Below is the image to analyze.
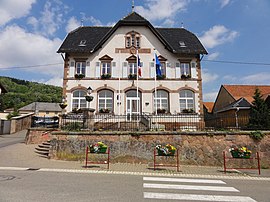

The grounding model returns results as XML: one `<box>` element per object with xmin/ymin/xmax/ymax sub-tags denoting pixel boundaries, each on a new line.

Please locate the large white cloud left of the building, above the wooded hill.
<box><xmin>0</xmin><ymin>25</ymin><xmax>63</xmax><ymax>80</ymax></box>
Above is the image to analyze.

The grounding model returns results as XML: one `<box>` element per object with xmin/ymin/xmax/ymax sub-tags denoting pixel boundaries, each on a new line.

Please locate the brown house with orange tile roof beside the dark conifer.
<box><xmin>206</xmin><ymin>85</ymin><xmax>270</xmax><ymax>128</ymax></box>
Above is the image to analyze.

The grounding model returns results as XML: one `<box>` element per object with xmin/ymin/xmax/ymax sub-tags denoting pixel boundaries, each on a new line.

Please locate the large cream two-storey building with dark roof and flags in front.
<box><xmin>57</xmin><ymin>12</ymin><xmax>207</xmax><ymax>131</ymax></box>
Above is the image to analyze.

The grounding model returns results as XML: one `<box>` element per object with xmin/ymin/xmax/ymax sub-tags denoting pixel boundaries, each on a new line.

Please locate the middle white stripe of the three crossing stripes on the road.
<box><xmin>143</xmin><ymin>183</ymin><xmax>239</xmax><ymax>192</ymax></box>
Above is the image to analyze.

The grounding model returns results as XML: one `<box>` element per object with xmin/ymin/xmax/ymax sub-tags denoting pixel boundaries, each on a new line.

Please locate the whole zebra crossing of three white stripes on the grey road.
<box><xmin>143</xmin><ymin>177</ymin><xmax>256</xmax><ymax>202</ymax></box>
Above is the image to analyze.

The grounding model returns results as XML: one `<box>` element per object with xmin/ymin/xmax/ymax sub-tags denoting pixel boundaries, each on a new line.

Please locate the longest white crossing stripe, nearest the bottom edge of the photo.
<box><xmin>143</xmin><ymin>192</ymin><xmax>256</xmax><ymax>202</ymax></box>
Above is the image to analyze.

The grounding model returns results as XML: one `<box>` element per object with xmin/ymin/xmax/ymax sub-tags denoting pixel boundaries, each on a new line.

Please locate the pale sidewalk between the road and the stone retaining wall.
<box><xmin>0</xmin><ymin>133</ymin><xmax>270</xmax><ymax>180</ymax></box>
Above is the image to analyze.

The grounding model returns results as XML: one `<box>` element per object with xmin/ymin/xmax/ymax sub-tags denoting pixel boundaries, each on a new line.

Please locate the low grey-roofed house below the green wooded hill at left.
<box><xmin>18</xmin><ymin>102</ymin><xmax>62</xmax><ymax>117</ymax></box>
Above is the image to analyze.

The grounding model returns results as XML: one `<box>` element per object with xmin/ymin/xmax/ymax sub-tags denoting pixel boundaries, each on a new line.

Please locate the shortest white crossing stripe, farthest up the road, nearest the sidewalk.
<box><xmin>143</xmin><ymin>177</ymin><xmax>226</xmax><ymax>184</ymax></box>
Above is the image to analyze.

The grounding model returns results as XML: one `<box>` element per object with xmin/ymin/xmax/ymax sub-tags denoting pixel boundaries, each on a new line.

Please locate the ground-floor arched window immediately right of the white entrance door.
<box><xmin>154</xmin><ymin>90</ymin><xmax>169</xmax><ymax>113</ymax></box>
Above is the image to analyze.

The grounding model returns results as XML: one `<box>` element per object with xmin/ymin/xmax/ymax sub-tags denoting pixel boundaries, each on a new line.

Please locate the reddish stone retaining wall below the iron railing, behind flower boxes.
<box><xmin>27</xmin><ymin>129</ymin><xmax>270</xmax><ymax>168</ymax></box>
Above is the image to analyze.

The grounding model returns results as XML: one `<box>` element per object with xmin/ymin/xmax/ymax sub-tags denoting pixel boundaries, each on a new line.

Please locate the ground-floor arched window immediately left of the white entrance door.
<box><xmin>98</xmin><ymin>90</ymin><xmax>113</xmax><ymax>113</ymax></box>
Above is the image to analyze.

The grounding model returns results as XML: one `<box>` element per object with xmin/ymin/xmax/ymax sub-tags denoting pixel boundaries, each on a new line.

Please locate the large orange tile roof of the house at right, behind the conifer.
<box><xmin>223</xmin><ymin>85</ymin><xmax>270</xmax><ymax>103</ymax></box>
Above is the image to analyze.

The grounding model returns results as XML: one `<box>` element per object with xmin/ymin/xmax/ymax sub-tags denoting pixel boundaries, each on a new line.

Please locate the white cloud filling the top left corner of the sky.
<box><xmin>0</xmin><ymin>0</ymin><xmax>36</xmax><ymax>26</ymax></box>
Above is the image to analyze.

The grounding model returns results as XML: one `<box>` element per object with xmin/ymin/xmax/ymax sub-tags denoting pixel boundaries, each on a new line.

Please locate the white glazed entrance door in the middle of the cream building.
<box><xmin>127</xmin><ymin>97</ymin><xmax>140</xmax><ymax>121</ymax></box>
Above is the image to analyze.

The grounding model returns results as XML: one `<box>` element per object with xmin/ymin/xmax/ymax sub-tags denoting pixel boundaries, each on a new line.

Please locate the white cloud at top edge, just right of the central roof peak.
<box><xmin>135</xmin><ymin>0</ymin><xmax>188</xmax><ymax>24</ymax></box>
